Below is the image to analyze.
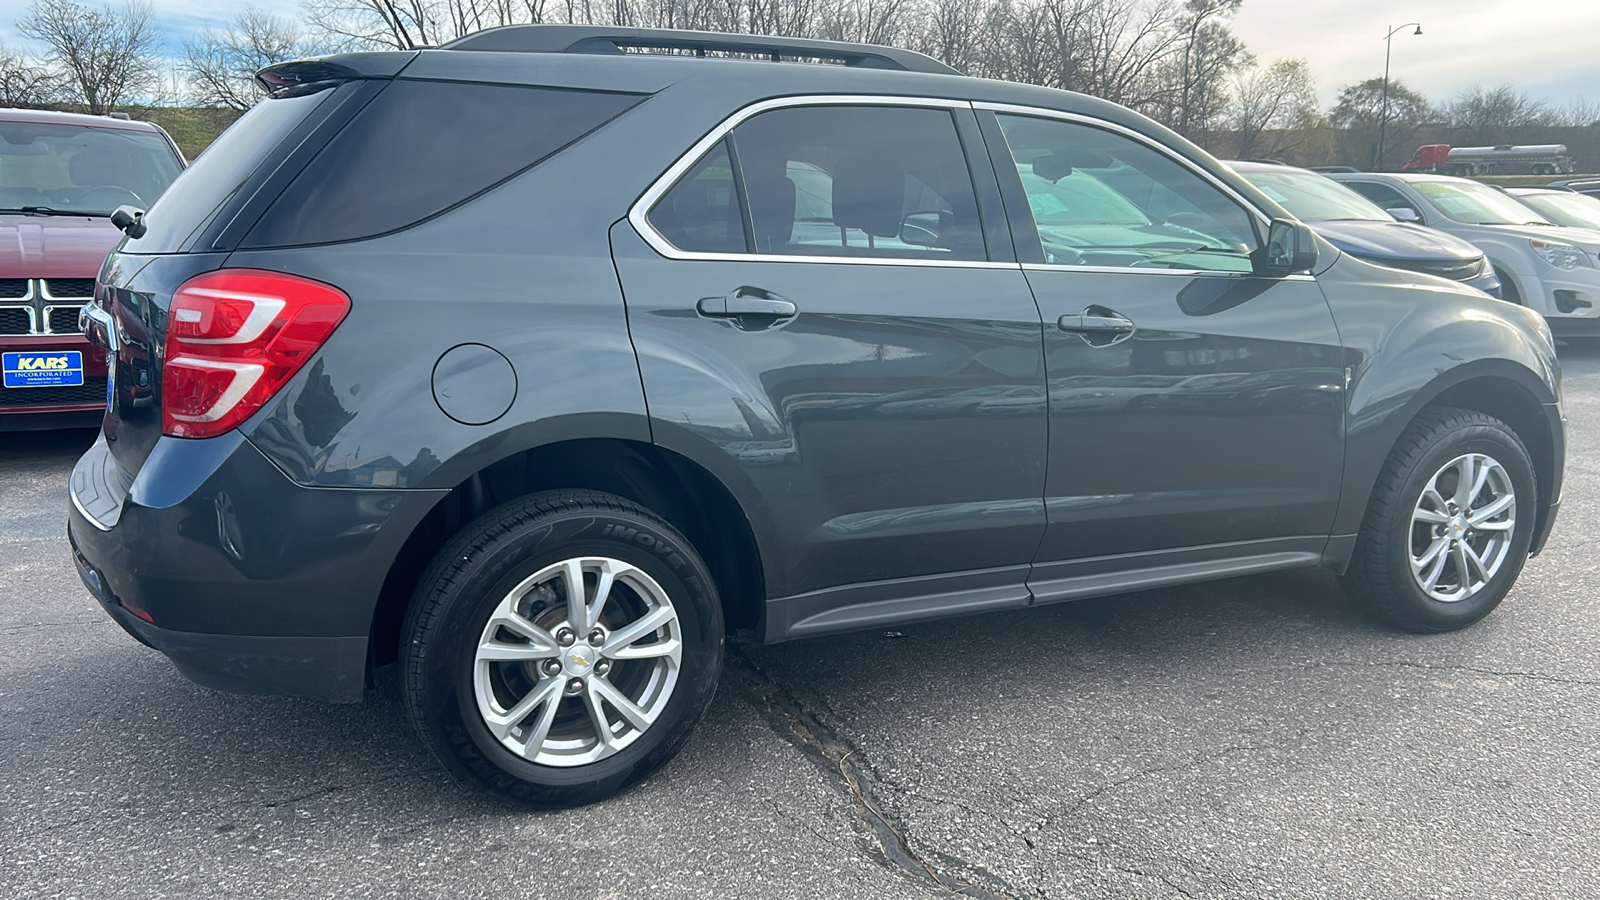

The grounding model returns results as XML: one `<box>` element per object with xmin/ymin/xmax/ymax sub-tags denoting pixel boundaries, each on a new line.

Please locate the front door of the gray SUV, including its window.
<box><xmin>979</xmin><ymin>109</ymin><xmax>1346</xmax><ymax>601</ymax></box>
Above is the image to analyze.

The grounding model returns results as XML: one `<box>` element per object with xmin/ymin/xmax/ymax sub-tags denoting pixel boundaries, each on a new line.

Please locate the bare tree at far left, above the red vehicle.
<box><xmin>16</xmin><ymin>0</ymin><xmax>160</xmax><ymax>114</ymax></box>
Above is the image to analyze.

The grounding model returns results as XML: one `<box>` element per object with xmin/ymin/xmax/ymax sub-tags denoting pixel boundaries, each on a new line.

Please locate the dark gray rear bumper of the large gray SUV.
<box><xmin>67</xmin><ymin>432</ymin><xmax>442</xmax><ymax>701</ymax></box>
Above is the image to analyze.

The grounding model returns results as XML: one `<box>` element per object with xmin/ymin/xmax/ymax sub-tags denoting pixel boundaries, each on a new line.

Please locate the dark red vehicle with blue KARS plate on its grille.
<box><xmin>0</xmin><ymin>109</ymin><xmax>186</xmax><ymax>431</ymax></box>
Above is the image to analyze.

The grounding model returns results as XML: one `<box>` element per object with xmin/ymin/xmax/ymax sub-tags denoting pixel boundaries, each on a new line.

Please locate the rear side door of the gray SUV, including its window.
<box><xmin>613</xmin><ymin>98</ymin><xmax>1048</xmax><ymax>639</ymax></box>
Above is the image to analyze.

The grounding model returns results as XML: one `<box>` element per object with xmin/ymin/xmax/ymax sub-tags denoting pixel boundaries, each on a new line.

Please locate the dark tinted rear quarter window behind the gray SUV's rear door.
<box><xmin>240</xmin><ymin>80</ymin><xmax>643</xmax><ymax>247</ymax></box>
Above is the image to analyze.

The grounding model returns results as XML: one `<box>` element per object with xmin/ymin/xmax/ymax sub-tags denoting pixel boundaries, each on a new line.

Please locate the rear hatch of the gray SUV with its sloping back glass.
<box><xmin>85</xmin><ymin>53</ymin><xmax>414</xmax><ymax>474</ymax></box>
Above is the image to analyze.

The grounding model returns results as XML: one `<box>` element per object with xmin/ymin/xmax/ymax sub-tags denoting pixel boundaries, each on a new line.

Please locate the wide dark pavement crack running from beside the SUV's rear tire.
<box><xmin>725</xmin><ymin>647</ymin><xmax>1018</xmax><ymax>900</ymax></box>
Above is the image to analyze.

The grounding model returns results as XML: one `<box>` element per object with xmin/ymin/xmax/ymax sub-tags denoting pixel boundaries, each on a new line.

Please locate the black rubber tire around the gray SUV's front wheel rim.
<box><xmin>1344</xmin><ymin>407</ymin><xmax>1538</xmax><ymax>634</ymax></box>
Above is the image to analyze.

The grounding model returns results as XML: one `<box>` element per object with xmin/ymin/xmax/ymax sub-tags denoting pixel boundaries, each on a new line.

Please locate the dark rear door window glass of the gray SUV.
<box><xmin>650</xmin><ymin>106</ymin><xmax>987</xmax><ymax>259</ymax></box>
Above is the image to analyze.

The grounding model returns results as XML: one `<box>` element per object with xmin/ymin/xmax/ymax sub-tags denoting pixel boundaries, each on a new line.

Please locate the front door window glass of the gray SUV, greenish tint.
<box><xmin>998</xmin><ymin>115</ymin><xmax>1258</xmax><ymax>272</ymax></box>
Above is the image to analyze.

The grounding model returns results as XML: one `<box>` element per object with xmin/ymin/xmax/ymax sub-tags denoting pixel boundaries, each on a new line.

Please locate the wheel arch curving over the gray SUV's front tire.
<box><xmin>1333</xmin><ymin>359</ymin><xmax>1560</xmax><ymax>554</ymax></box>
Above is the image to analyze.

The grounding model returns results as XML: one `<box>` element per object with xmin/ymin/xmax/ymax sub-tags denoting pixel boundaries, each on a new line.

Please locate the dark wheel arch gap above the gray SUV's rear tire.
<box><xmin>370</xmin><ymin>428</ymin><xmax>770</xmax><ymax>665</ymax></box>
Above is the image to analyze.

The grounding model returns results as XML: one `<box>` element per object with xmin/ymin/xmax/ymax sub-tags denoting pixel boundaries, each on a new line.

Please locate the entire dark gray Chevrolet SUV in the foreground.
<box><xmin>69</xmin><ymin>26</ymin><xmax>1565</xmax><ymax>806</ymax></box>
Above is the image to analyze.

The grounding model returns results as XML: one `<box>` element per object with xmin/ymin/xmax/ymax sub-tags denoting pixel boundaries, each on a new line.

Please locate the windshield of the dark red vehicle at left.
<box><xmin>0</xmin><ymin>122</ymin><xmax>179</xmax><ymax>216</ymax></box>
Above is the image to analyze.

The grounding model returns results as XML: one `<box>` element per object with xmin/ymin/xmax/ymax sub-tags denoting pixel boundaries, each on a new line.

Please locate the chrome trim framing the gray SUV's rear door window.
<box><xmin>627</xmin><ymin>94</ymin><xmax>1021</xmax><ymax>271</ymax></box>
